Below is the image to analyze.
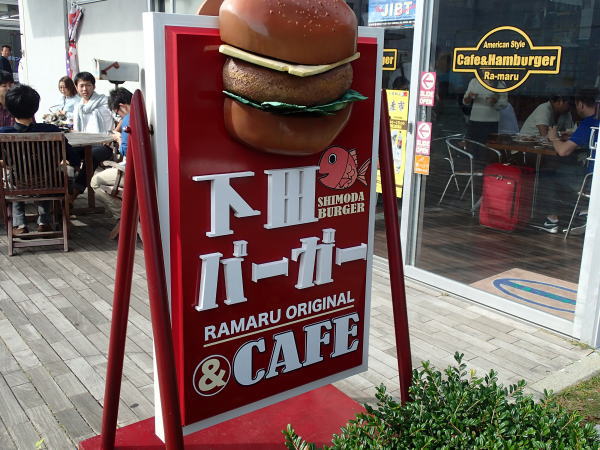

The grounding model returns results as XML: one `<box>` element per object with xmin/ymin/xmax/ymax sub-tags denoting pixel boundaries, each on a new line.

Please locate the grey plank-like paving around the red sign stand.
<box><xmin>0</xmin><ymin>216</ymin><xmax>600</xmax><ymax>449</ymax></box>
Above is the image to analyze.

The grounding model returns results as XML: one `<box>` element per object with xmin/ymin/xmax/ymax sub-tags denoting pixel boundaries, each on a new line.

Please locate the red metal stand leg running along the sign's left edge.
<box><xmin>130</xmin><ymin>90</ymin><xmax>183</xmax><ymax>449</ymax></box>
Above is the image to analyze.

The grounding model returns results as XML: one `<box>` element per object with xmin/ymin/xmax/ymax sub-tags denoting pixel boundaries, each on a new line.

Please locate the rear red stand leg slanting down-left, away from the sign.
<box><xmin>102</xmin><ymin>139</ymin><xmax>138</xmax><ymax>450</ymax></box>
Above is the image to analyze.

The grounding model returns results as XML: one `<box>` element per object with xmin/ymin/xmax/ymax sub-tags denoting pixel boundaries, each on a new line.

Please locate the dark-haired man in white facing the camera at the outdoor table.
<box><xmin>71</xmin><ymin>72</ymin><xmax>114</xmax><ymax>201</ymax></box>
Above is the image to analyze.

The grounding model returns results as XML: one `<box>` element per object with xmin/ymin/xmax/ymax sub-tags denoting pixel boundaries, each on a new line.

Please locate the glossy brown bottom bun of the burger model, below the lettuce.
<box><xmin>224</xmin><ymin>98</ymin><xmax>352</xmax><ymax>155</ymax></box>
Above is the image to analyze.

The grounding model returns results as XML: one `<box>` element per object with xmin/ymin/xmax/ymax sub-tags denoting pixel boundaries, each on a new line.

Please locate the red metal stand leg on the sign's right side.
<box><xmin>379</xmin><ymin>90</ymin><xmax>412</xmax><ymax>403</ymax></box>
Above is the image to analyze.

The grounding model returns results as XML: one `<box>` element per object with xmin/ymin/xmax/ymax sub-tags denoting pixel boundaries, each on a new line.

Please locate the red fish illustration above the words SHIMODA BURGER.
<box><xmin>319</xmin><ymin>147</ymin><xmax>371</xmax><ymax>189</ymax></box>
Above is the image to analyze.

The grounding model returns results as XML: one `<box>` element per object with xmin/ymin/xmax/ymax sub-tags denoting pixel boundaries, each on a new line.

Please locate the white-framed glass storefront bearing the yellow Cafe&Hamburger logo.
<box><xmin>151</xmin><ymin>0</ymin><xmax>600</xmax><ymax>346</ymax></box>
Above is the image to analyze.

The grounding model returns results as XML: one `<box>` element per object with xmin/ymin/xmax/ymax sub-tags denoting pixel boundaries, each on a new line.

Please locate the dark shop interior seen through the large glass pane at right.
<box><xmin>366</xmin><ymin>0</ymin><xmax>600</xmax><ymax>320</ymax></box>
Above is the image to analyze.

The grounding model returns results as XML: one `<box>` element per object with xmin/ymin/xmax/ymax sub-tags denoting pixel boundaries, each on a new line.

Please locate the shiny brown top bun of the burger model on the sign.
<box><xmin>219</xmin><ymin>0</ymin><xmax>357</xmax><ymax>65</ymax></box>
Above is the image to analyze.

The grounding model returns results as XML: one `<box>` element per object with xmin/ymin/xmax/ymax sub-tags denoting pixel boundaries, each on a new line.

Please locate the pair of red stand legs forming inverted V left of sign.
<box><xmin>102</xmin><ymin>90</ymin><xmax>183</xmax><ymax>449</ymax></box>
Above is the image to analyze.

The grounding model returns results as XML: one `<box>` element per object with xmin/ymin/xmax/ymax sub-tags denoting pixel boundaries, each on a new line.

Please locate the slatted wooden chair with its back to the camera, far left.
<box><xmin>0</xmin><ymin>133</ymin><xmax>69</xmax><ymax>256</ymax></box>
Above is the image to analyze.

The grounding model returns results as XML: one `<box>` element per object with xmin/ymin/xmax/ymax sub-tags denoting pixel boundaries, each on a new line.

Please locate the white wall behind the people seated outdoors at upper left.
<box><xmin>19</xmin><ymin>0</ymin><xmax>148</xmax><ymax>121</ymax></box>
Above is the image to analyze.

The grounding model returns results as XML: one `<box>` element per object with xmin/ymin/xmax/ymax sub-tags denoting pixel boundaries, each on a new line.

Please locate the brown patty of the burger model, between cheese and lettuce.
<box><xmin>223</xmin><ymin>58</ymin><xmax>352</xmax><ymax>106</ymax></box>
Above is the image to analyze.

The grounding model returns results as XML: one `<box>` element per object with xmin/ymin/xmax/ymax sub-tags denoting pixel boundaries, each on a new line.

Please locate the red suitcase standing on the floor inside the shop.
<box><xmin>479</xmin><ymin>163</ymin><xmax>534</xmax><ymax>231</ymax></box>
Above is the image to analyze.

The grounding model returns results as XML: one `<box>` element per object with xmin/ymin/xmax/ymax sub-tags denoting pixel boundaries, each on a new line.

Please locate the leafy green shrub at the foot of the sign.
<box><xmin>283</xmin><ymin>353</ymin><xmax>600</xmax><ymax>450</ymax></box>
